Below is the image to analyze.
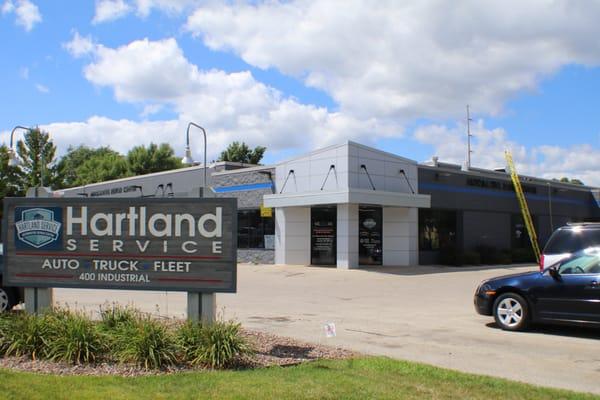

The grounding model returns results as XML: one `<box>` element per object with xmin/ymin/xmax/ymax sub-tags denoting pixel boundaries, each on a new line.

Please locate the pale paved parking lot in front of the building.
<box><xmin>55</xmin><ymin>265</ymin><xmax>600</xmax><ymax>394</ymax></box>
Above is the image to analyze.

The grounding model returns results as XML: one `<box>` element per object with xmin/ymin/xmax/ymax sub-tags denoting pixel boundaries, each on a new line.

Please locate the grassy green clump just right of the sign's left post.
<box><xmin>46</xmin><ymin>312</ymin><xmax>107</xmax><ymax>364</ymax></box>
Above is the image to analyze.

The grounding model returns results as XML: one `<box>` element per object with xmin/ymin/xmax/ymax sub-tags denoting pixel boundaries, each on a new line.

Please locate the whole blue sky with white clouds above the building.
<box><xmin>0</xmin><ymin>0</ymin><xmax>600</xmax><ymax>185</ymax></box>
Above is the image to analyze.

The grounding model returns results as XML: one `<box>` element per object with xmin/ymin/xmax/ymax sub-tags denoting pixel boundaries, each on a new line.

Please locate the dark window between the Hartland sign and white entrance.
<box><xmin>238</xmin><ymin>209</ymin><xmax>275</xmax><ymax>249</ymax></box>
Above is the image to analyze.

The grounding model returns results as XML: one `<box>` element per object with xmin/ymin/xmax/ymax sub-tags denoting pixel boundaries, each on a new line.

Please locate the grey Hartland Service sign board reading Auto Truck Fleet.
<box><xmin>3</xmin><ymin>198</ymin><xmax>237</xmax><ymax>292</ymax></box>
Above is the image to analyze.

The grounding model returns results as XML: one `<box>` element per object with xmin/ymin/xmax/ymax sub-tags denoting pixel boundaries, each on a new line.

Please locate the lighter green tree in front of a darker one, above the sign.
<box><xmin>74</xmin><ymin>150</ymin><xmax>129</xmax><ymax>186</ymax></box>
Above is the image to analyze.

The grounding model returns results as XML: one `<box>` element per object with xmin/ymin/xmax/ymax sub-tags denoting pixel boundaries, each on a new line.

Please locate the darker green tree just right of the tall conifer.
<box><xmin>56</xmin><ymin>145</ymin><xmax>119</xmax><ymax>188</ymax></box>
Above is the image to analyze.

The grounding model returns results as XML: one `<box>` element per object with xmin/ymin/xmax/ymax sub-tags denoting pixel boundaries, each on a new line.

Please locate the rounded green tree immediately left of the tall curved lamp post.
<box><xmin>127</xmin><ymin>143</ymin><xmax>182</xmax><ymax>175</ymax></box>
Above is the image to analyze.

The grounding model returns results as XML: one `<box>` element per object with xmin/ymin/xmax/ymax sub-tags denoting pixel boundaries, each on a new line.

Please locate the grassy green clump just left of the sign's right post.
<box><xmin>113</xmin><ymin>317</ymin><xmax>178</xmax><ymax>369</ymax></box>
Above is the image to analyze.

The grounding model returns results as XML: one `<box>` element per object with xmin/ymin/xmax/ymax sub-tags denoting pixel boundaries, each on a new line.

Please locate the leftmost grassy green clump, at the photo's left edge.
<box><xmin>4</xmin><ymin>314</ymin><xmax>52</xmax><ymax>360</ymax></box>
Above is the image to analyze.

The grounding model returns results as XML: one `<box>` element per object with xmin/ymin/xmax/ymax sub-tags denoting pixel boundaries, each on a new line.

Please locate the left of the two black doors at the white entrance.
<box><xmin>310</xmin><ymin>206</ymin><xmax>337</xmax><ymax>265</ymax></box>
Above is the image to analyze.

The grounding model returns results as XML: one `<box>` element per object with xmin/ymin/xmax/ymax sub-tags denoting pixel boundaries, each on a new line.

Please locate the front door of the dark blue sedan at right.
<box><xmin>532</xmin><ymin>255</ymin><xmax>600</xmax><ymax>323</ymax></box>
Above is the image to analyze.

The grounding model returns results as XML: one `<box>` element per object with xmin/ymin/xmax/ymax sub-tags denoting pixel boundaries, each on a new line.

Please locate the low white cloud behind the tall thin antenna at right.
<box><xmin>414</xmin><ymin>120</ymin><xmax>600</xmax><ymax>186</ymax></box>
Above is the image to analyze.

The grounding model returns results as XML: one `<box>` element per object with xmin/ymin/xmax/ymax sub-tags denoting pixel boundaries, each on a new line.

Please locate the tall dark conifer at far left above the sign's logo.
<box><xmin>17</xmin><ymin>128</ymin><xmax>57</xmax><ymax>189</ymax></box>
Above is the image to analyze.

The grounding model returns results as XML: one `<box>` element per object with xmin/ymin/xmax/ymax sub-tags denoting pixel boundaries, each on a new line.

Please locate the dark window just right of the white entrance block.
<box><xmin>419</xmin><ymin>209</ymin><xmax>456</xmax><ymax>251</ymax></box>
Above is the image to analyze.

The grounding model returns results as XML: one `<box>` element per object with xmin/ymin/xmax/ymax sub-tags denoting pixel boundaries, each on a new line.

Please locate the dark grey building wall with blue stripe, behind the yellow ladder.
<box><xmin>419</xmin><ymin>166</ymin><xmax>600</xmax><ymax>263</ymax></box>
